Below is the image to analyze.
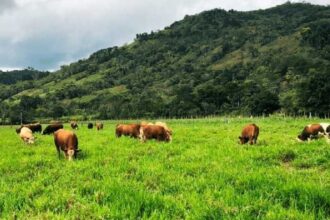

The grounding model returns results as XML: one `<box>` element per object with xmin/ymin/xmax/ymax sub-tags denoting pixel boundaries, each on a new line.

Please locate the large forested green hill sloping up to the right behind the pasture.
<box><xmin>0</xmin><ymin>3</ymin><xmax>330</xmax><ymax>122</ymax></box>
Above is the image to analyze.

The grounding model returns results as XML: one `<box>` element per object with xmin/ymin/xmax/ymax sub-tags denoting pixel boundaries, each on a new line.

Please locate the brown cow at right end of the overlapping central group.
<box><xmin>139</xmin><ymin>125</ymin><xmax>172</xmax><ymax>142</ymax></box>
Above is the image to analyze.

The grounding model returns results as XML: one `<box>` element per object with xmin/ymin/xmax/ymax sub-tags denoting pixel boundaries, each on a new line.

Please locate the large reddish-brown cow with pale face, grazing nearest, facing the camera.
<box><xmin>54</xmin><ymin>129</ymin><xmax>80</xmax><ymax>160</ymax></box>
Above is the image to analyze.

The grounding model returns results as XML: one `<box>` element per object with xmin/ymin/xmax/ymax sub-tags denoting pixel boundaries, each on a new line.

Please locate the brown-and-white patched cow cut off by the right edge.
<box><xmin>297</xmin><ymin>123</ymin><xmax>330</xmax><ymax>141</ymax></box>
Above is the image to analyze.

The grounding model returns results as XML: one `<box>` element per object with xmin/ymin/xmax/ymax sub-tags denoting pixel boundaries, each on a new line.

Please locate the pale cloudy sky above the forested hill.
<box><xmin>0</xmin><ymin>0</ymin><xmax>330</xmax><ymax>71</ymax></box>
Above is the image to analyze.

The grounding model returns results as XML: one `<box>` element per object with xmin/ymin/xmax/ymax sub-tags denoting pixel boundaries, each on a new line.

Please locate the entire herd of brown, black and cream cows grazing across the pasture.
<box><xmin>16</xmin><ymin>121</ymin><xmax>330</xmax><ymax>160</ymax></box>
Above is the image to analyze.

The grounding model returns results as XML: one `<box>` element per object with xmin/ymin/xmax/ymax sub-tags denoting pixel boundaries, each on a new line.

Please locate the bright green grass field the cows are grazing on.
<box><xmin>0</xmin><ymin>118</ymin><xmax>330</xmax><ymax>219</ymax></box>
